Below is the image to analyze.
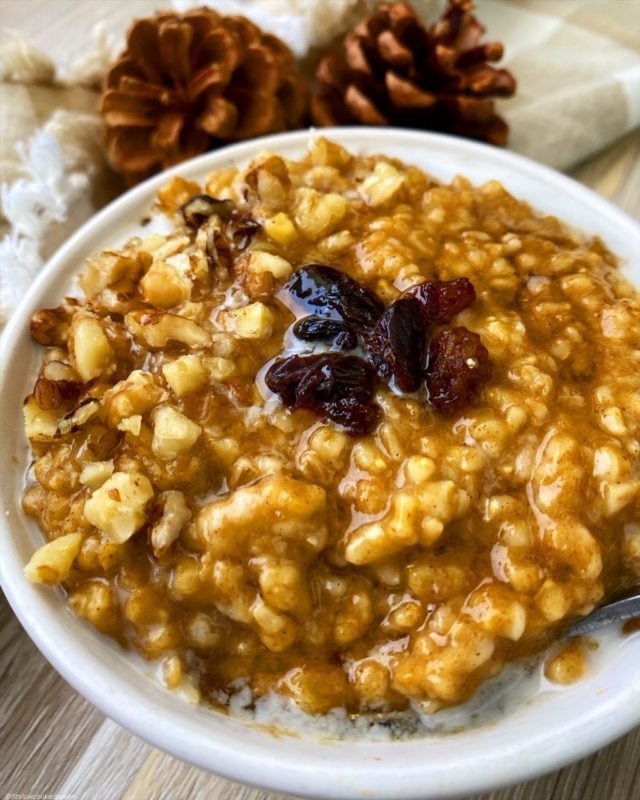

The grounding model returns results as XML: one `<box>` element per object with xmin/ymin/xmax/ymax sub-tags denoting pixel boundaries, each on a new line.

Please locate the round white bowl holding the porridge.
<box><xmin>0</xmin><ymin>128</ymin><xmax>640</xmax><ymax>800</ymax></box>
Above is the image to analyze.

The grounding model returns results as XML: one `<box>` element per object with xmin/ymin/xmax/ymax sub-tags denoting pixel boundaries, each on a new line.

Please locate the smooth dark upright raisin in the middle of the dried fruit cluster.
<box><xmin>366</xmin><ymin>297</ymin><xmax>427</xmax><ymax>392</ymax></box>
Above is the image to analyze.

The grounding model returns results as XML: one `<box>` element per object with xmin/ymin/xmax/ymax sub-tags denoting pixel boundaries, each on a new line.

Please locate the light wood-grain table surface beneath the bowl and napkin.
<box><xmin>0</xmin><ymin>0</ymin><xmax>640</xmax><ymax>800</ymax></box>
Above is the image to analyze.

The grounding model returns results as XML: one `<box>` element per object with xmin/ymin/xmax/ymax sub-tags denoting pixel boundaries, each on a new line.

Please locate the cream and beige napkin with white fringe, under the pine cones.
<box><xmin>0</xmin><ymin>0</ymin><xmax>640</xmax><ymax>327</ymax></box>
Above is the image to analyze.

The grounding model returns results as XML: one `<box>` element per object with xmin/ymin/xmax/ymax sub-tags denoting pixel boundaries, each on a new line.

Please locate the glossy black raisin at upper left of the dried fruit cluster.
<box><xmin>286</xmin><ymin>264</ymin><xmax>384</xmax><ymax>332</ymax></box>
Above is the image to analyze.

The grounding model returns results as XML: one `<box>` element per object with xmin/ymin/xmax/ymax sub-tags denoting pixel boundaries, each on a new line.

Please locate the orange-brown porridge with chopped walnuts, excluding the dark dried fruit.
<box><xmin>23</xmin><ymin>138</ymin><xmax>640</xmax><ymax>713</ymax></box>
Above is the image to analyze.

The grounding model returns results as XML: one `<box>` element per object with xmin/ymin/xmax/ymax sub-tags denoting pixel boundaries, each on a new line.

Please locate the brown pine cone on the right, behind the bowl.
<box><xmin>311</xmin><ymin>0</ymin><xmax>516</xmax><ymax>145</ymax></box>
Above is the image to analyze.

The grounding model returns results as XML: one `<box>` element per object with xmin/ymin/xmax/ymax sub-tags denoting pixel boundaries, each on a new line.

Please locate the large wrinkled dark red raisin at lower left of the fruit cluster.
<box><xmin>265</xmin><ymin>353</ymin><xmax>380</xmax><ymax>436</ymax></box>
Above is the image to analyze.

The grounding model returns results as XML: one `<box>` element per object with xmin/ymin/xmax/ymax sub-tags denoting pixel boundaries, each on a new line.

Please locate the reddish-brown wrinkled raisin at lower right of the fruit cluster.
<box><xmin>426</xmin><ymin>328</ymin><xmax>491</xmax><ymax>413</ymax></box>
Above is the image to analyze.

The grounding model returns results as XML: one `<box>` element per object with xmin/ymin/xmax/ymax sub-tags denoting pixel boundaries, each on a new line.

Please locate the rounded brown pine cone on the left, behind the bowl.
<box><xmin>100</xmin><ymin>8</ymin><xmax>306</xmax><ymax>184</ymax></box>
